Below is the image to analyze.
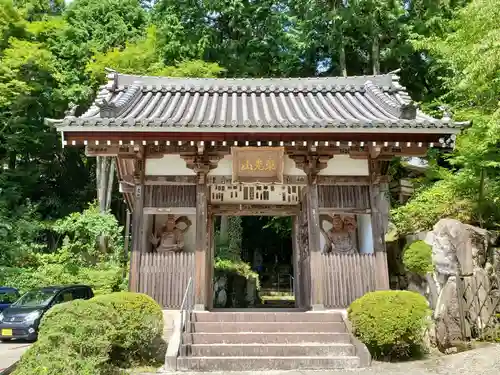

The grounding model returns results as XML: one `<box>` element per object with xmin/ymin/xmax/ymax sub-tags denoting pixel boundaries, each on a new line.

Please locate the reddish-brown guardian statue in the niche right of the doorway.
<box><xmin>320</xmin><ymin>215</ymin><xmax>358</xmax><ymax>254</ymax></box>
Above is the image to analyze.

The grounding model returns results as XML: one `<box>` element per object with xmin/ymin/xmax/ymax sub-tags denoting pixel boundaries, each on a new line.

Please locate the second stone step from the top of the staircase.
<box><xmin>191</xmin><ymin>322</ymin><xmax>346</xmax><ymax>333</ymax></box>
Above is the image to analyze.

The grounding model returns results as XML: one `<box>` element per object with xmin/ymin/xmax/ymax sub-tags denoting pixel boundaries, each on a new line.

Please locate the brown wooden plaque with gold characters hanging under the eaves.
<box><xmin>231</xmin><ymin>147</ymin><xmax>284</xmax><ymax>184</ymax></box>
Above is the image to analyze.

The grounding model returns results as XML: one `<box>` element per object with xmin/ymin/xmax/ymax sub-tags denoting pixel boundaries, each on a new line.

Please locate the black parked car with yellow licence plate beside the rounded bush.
<box><xmin>0</xmin><ymin>285</ymin><xmax>94</xmax><ymax>342</ymax></box>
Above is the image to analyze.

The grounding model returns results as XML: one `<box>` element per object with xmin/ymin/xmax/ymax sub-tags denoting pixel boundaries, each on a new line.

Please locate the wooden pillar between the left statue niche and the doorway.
<box><xmin>194</xmin><ymin>166</ymin><xmax>209</xmax><ymax>310</ymax></box>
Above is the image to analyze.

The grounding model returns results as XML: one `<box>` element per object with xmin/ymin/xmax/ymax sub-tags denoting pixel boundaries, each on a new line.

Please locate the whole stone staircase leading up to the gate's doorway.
<box><xmin>177</xmin><ymin>311</ymin><xmax>369</xmax><ymax>372</ymax></box>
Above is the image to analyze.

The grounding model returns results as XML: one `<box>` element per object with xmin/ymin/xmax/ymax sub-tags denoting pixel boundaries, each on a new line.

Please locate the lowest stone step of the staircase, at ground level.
<box><xmin>177</xmin><ymin>357</ymin><xmax>360</xmax><ymax>372</ymax></box>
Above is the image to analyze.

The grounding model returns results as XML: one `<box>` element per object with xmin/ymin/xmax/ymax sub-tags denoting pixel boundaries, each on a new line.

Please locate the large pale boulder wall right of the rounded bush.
<box><xmin>425</xmin><ymin>219</ymin><xmax>500</xmax><ymax>351</ymax></box>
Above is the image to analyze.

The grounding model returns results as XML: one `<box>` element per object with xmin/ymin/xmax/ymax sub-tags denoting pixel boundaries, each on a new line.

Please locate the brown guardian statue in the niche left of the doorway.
<box><xmin>151</xmin><ymin>215</ymin><xmax>191</xmax><ymax>254</ymax></box>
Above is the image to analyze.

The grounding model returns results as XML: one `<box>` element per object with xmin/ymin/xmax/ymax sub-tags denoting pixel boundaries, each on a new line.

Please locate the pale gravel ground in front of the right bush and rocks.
<box><xmin>152</xmin><ymin>344</ymin><xmax>500</xmax><ymax>375</ymax></box>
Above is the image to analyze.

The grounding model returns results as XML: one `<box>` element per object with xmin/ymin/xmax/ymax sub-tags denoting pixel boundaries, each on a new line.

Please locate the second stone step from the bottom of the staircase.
<box><xmin>185</xmin><ymin>343</ymin><xmax>355</xmax><ymax>357</ymax></box>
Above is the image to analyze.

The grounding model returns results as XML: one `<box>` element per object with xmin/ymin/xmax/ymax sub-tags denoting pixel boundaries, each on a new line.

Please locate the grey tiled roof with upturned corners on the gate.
<box><xmin>57</xmin><ymin>73</ymin><xmax>462</xmax><ymax>131</ymax></box>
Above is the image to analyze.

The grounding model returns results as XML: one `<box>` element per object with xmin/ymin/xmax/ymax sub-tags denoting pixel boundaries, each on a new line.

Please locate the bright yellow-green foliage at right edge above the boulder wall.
<box><xmin>393</xmin><ymin>0</ymin><xmax>500</xmax><ymax>233</ymax></box>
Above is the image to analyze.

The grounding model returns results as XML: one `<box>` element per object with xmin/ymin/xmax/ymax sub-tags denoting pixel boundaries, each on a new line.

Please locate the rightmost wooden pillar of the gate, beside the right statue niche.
<box><xmin>370</xmin><ymin>159</ymin><xmax>390</xmax><ymax>290</ymax></box>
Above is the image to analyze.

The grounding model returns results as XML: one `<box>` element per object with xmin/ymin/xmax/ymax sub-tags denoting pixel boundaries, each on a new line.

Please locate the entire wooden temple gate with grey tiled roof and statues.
<box><xmin>51</xmin><ymin>73</ymin><xmax>464</xmax><ymax>309</ymax></box>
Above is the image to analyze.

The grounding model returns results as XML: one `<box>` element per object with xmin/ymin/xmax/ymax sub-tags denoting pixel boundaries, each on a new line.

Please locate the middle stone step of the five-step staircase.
<box><xmin>183</xmin><ymin>332</ymin><xmax>351</xmax><ymax>345</ymax></box>
